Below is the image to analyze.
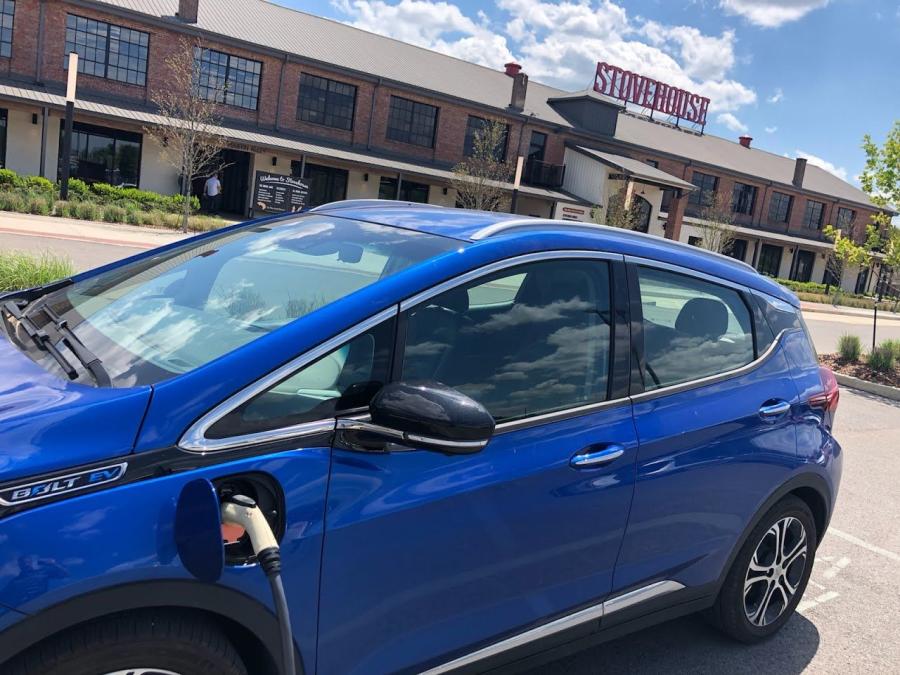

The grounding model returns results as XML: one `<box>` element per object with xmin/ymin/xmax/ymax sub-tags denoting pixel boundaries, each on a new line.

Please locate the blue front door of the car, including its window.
<box><xmin>318</xmin><ymin>253</ymin><xmax>636</xmax><ymax>673</ymax></box>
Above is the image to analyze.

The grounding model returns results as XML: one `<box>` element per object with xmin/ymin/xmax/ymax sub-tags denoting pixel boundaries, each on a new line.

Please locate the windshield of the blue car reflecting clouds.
<box><xmin>15</xmin><ymin>214</ymin><xmax>460</xmax><ymax>387</ymax></box>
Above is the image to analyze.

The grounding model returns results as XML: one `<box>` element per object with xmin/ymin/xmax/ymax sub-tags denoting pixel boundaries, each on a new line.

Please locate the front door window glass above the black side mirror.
<box><xmin>402</xmin><ymin>260</ymin><xmax>610</xmax><ymax>422</ymax></box>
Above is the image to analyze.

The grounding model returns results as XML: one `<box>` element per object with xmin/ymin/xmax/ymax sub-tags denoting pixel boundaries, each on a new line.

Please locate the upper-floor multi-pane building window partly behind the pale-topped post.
<box><xmin>64</xmin><ymin>14</ymin><xmax>150</xmax><ymax>87</ymax></box>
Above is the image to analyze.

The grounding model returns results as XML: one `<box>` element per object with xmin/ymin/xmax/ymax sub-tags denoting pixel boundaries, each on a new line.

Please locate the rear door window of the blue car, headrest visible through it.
<box><xmin>638</xmin><ymin>267</ymin><xmax>755</xmax><ymax>390</ymax></box>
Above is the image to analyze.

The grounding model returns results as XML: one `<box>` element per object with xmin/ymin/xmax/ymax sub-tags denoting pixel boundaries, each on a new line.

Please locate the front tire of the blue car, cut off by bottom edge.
<box><xmin>3</xmin><ymin>610</ymin><xmax>247</xmax><ymax>675</ymax></box>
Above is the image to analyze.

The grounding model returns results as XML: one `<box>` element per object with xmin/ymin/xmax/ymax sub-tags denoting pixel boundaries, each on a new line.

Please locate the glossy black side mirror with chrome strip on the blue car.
<box><xmin>339</xmin><ymin>381</ymin><xmax>494</xmax><ymax>455</ymax></box>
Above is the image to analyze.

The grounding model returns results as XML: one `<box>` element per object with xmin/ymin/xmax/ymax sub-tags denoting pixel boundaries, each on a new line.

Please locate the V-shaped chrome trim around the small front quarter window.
<box><xmin>178</xmin><ymin>305</ymin><xmax>399</xmax><ymax>454</ymax></box>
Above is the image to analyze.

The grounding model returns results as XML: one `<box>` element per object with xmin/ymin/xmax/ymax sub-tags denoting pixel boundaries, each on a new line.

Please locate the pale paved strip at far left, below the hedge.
<box><xmin>0</xmin><ymin>211</ymin><xmax>191</xmax><ymax>249</ymax></box>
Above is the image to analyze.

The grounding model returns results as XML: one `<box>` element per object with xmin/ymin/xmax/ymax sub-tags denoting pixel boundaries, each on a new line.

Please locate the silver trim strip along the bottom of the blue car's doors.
<box><xmin>421</xmin><ymin>579</ymin><xmax>684</xmax><ymax>675</ymax></box>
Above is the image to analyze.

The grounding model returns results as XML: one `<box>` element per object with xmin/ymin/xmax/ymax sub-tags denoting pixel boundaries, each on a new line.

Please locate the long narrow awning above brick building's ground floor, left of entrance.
<box><xmin>0</xmin><ymin>84</ymin><xmax>574</xmax><ymax>201</ymax></box>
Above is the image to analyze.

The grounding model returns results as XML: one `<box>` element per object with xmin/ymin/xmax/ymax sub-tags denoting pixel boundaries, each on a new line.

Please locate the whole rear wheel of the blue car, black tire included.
<box><xmin>708</xmin><ymin>495</ymin><xmax>818</xmax><ymax>643</ymax></box>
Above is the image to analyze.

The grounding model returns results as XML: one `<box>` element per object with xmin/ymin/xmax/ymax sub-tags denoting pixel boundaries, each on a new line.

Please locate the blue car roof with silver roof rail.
<box><xmin>312</xmin><ymin>199</ymin><xmax>799</xmax><ymax>306</ymax></box>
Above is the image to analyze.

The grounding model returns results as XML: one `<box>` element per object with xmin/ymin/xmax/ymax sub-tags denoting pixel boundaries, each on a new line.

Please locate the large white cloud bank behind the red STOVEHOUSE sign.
<box><xmin>332</xmin><ymin>0</ymin><xmax>756</xmax><ymax>113</ymax></box>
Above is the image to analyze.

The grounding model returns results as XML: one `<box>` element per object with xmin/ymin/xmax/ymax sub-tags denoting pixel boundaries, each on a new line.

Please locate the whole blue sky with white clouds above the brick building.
<box><xmin>276</xmin><ymin>0</ymin><xmax>900</xmax><ymax>182</ymax></box>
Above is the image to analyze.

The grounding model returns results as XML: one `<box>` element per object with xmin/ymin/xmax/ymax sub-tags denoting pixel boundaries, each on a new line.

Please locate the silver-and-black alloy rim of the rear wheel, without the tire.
<box><xmin>744</xmin><ymin>516</ymin><xmax>808</xmax><ymax>627</ymax></box>
